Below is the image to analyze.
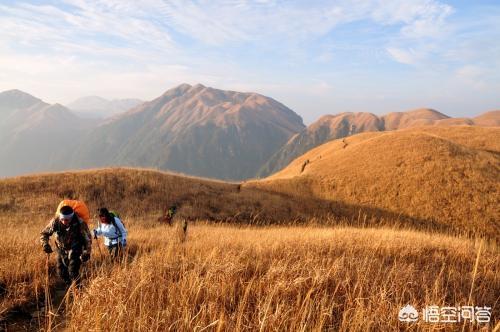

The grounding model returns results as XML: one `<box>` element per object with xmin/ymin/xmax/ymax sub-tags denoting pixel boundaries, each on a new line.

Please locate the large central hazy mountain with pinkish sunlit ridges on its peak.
<box><xmin>74</xmin><ymin>84</ymin><xmax>304</xmax><ymax>179</ymax></box>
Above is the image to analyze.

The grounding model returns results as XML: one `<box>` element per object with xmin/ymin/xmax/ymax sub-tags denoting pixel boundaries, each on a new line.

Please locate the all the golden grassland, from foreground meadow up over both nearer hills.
<box><xmin>0</xmin><ymin>127</ymin><xmax>500</xmax><ymax>331</ymax></box>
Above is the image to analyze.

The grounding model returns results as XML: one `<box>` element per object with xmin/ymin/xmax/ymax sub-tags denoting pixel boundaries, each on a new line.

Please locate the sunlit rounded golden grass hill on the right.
<box><xmin>249</xmin><ymin>127</ymin><xmax>500</xmax><ymax>238</ymax></box>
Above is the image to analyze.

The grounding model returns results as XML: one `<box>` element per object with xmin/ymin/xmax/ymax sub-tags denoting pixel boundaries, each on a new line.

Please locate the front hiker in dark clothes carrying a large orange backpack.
<box><xmin>40</xmin><ymin>205</ymin><xmax>92</xmax><ymax>285</ymax></box>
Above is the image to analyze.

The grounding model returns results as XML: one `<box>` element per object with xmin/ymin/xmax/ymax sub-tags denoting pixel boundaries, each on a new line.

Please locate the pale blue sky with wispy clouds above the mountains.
<box><xmin>0</xmin><ymin>0</ymin><xmax>500</xmax><ymax>124</ymax></box>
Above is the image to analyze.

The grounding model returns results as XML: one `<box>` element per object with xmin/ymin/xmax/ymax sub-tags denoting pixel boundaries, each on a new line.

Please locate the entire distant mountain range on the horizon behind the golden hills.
<box><xmin>0</xmin><ymin>84</ymin><xmax>500</xmax><ymax>180</ymax></box>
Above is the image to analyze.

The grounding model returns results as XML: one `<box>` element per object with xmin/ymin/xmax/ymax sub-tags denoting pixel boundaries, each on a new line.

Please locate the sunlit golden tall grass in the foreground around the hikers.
<box><xmin>0</xmin><ymin>218</ymin><xmax>500</xmax><ymax>331</ymax></box>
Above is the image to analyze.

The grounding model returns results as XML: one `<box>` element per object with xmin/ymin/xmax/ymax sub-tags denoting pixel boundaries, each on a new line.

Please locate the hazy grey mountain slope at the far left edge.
<box><xmin>0</xmin><ymin>90</ymin><xmax>91</xmax><ymax>176</ymax></box>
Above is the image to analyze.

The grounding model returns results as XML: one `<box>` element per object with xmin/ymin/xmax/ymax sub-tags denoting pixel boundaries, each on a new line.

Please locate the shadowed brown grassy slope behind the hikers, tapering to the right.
<box><xmin>0</xmin><ymin>168</ymin><xmax>476</xmax><ymax>233</ymax></box>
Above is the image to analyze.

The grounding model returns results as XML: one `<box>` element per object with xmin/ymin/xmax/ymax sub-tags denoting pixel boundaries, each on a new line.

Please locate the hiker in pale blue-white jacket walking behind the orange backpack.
<box><xmin>94</xmin><ymin>207</ymin><xmax>127</xmax><ymax>258</ymax></box>
